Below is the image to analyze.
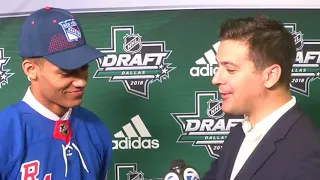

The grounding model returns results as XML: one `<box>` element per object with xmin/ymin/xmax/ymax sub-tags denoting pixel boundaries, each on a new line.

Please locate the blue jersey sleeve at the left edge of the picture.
<box><xmin>0</xmin><ymin>107</ymin><xmax>24</xmax><ymax>180</ymax></box>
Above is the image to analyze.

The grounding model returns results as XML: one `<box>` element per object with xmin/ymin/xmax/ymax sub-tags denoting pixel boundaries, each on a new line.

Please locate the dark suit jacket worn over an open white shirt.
<box><xmin>202</xmin><ymin>105</ymin><xmax>320</xmax><ymax>180</ymax></box>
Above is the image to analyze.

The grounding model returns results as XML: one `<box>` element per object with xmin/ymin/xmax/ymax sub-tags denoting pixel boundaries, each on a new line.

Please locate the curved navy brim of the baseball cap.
<box><xmin>44</xmin><ymin>44</ymin><xmax>104</xmax><ymax>70</ymax></box>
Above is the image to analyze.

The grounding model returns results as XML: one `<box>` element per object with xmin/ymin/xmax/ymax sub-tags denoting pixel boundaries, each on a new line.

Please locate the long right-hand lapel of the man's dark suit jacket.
<box><xmin>235</xmin><ymin>105</ymin><xmax>302</xmax><ymax>180</ymax></box>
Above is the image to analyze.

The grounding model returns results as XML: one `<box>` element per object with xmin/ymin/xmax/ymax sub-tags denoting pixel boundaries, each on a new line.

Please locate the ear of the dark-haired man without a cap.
<box><xmin>264</xmin><ymin>64</ymin><xmax>282</xmax><ymax>89</ymax></box>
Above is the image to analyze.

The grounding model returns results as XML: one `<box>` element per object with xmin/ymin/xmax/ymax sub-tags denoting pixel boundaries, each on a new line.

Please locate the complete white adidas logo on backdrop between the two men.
<box><xmin>112</xmin><ymin>115</ymin><xmax>159</xmax><ymax>149</ymax></box>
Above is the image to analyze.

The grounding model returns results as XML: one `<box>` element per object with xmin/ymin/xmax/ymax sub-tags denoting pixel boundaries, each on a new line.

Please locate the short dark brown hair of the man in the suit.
<box><xmin>219</xmin><ymin>15</ymin><xmax>297</xmax><ymax>88</ymax></box>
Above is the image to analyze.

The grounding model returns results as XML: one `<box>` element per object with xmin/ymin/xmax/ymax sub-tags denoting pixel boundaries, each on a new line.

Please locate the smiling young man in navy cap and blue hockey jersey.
<box><xmin>0</xmin><ymin>7</ymin><xmax>112</xmax><ymax>180</ymax></box>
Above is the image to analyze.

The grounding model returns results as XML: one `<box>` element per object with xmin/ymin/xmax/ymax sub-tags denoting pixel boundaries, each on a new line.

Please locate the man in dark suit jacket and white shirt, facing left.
<box><xmin>202</xmin><ymin>16</ymin><xmax>320</xmax><ymax>180</ymax></box>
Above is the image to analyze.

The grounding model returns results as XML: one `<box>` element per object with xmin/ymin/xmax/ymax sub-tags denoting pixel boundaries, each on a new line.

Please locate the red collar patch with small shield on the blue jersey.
<box><xmin>53</xmin><ymin>120</ymin><xmax>72</xmax><ymax>144</ymax></box>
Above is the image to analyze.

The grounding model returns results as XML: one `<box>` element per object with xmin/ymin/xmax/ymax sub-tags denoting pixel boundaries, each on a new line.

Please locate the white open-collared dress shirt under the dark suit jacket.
<box><xmin>230</xmin><ymin>96</ymin><xmax>296</xmax><ymax>180</ymax></box>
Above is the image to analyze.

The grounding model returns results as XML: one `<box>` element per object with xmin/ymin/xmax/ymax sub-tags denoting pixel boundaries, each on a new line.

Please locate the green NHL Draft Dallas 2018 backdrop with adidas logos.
<box><xmin>0</xmin><ymin>4</ymin><xmax>320</xmax><ymax>180</ymax></box>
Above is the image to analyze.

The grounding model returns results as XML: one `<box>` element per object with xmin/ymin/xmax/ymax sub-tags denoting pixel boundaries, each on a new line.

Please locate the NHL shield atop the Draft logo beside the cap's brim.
<box><xmin>123</xmin><ymin>34</ymin><xmax>142</xmax><ymax>54</ymax></box>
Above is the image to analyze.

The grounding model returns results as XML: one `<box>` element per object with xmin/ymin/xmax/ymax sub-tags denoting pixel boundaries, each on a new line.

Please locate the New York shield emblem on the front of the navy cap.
<box><xmin>59</xmin><ymin>19</ymin><xmax>81</xmax><ymax>42</ymax></box>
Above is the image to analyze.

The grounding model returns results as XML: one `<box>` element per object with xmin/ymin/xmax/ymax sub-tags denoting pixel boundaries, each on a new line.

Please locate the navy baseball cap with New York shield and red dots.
<box><xmin>19</xmin><ymin>7</ymin><xmax>103</xmax><ymax>70</ymax></box>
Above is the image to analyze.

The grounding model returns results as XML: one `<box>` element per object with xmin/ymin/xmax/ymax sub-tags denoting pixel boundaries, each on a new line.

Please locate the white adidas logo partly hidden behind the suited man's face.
<box><xmin>190</xmin><ymin>41</ymin><xmax>220</xmax><ymax>77</ymax></box>
